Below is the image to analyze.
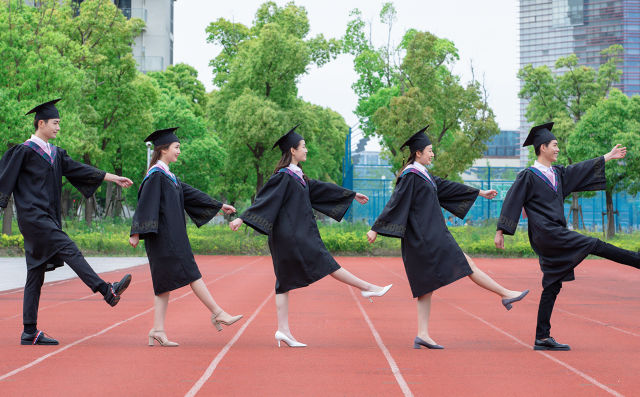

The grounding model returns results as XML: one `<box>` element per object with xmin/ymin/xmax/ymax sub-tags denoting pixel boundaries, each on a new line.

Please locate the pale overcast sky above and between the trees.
<box><xmin>174</xmin><ymin>0</ymin><xmax>519</xmax><ymax>130</ymax></box>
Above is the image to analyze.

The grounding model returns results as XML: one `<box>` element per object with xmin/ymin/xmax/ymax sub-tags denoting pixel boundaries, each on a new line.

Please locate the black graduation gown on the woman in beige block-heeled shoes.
<box><xmin>130</xmin><ymin>167</ymin><xmax>222</xmax><ymax>295</ymax></box>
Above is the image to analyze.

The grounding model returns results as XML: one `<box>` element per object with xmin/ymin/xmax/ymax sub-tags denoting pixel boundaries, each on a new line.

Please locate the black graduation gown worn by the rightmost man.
<box><xmin>498</xmin><ymin>157</ymin><xmax>607</xmax><ymax>287</ymax></box>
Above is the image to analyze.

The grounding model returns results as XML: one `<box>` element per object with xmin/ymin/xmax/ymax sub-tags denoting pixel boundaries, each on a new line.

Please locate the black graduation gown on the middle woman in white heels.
<box><xmin>240</xmin><ymin>169</ymin><xmax>356</xmax><ymax>294</ymax></box>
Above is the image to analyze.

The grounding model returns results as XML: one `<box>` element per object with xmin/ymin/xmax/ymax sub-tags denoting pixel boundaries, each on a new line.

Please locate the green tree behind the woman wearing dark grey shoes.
<box><xmin>344</xmin><ymin>3</ymin><xmax>499</xmax><ymax>179</ymax></box>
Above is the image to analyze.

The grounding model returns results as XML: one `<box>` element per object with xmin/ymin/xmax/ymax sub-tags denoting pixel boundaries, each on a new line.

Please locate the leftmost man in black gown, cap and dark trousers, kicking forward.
<box><xmin>0</xmin><ymin>99</ymin><xmax>132</xmax><ymax>345</ymax></box>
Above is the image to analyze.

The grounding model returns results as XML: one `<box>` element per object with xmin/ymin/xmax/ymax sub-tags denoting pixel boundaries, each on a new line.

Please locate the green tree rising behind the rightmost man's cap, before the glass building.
<box><xmin>518</xmin><ymin>45</ymin><xmax>622</xmax><ymax>229</ymax></box>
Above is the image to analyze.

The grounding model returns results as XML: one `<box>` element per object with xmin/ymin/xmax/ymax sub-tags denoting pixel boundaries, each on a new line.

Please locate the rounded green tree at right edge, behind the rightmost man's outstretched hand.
<box><xmin>567</xmin><ymin>88</ymin><xmax>640</xmax><ymax>238</ymax></box>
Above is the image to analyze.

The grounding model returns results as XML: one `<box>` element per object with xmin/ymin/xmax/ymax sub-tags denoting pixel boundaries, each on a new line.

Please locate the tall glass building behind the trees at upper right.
<box><xmin>519</xmin><ymin>0</ymin><xmax>640</xmax><ymax>166</ymax></box>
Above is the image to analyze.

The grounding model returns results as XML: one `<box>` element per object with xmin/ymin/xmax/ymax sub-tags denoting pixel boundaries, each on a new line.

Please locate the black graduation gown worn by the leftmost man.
<box><xmin>0</xmin><ymin>141</ymin><xmax>106</xmax><ymax>271</ymax></box>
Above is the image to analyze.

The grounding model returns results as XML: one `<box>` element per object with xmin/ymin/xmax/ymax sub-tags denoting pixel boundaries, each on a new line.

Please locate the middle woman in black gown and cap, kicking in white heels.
<box><xmin>229</xmin><ymin>126</ymin><xmax>391</xmax><ymax>347</ymax></box>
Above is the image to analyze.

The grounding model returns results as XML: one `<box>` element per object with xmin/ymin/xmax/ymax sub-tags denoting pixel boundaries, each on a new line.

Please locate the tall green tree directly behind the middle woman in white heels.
<box><xmin>207</xmin><ymin>2</ymin><xmax>347</xmax><ymax>202</ymax></box>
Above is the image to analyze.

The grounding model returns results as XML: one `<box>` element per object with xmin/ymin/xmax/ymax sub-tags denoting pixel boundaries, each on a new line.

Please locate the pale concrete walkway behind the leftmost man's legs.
<box><xmin>0</xmin><ymin>256</ymin><xmax>149</xmax><ymax>291</ymax></box>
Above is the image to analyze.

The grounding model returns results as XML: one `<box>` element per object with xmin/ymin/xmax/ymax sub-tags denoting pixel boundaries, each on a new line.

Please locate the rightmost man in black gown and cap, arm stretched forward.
<box><xmin>495</xmin><ymin>123</ymin><xmax>640</xmax><ymax>350</ymax></box>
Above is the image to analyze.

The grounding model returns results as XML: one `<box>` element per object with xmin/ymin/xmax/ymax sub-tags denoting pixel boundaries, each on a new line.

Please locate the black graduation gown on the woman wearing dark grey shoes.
<box><xmin>371</xmin><ymin>169</ymin><xmax>479</xmax><ymax>298</ymax></box>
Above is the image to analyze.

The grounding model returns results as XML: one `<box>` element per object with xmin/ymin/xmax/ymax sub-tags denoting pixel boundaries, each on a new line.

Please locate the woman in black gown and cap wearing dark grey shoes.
<box><xmin>367</xmin><ymin>126</ymin><xmax>529</xmax><ymax>349</ymax></box>
